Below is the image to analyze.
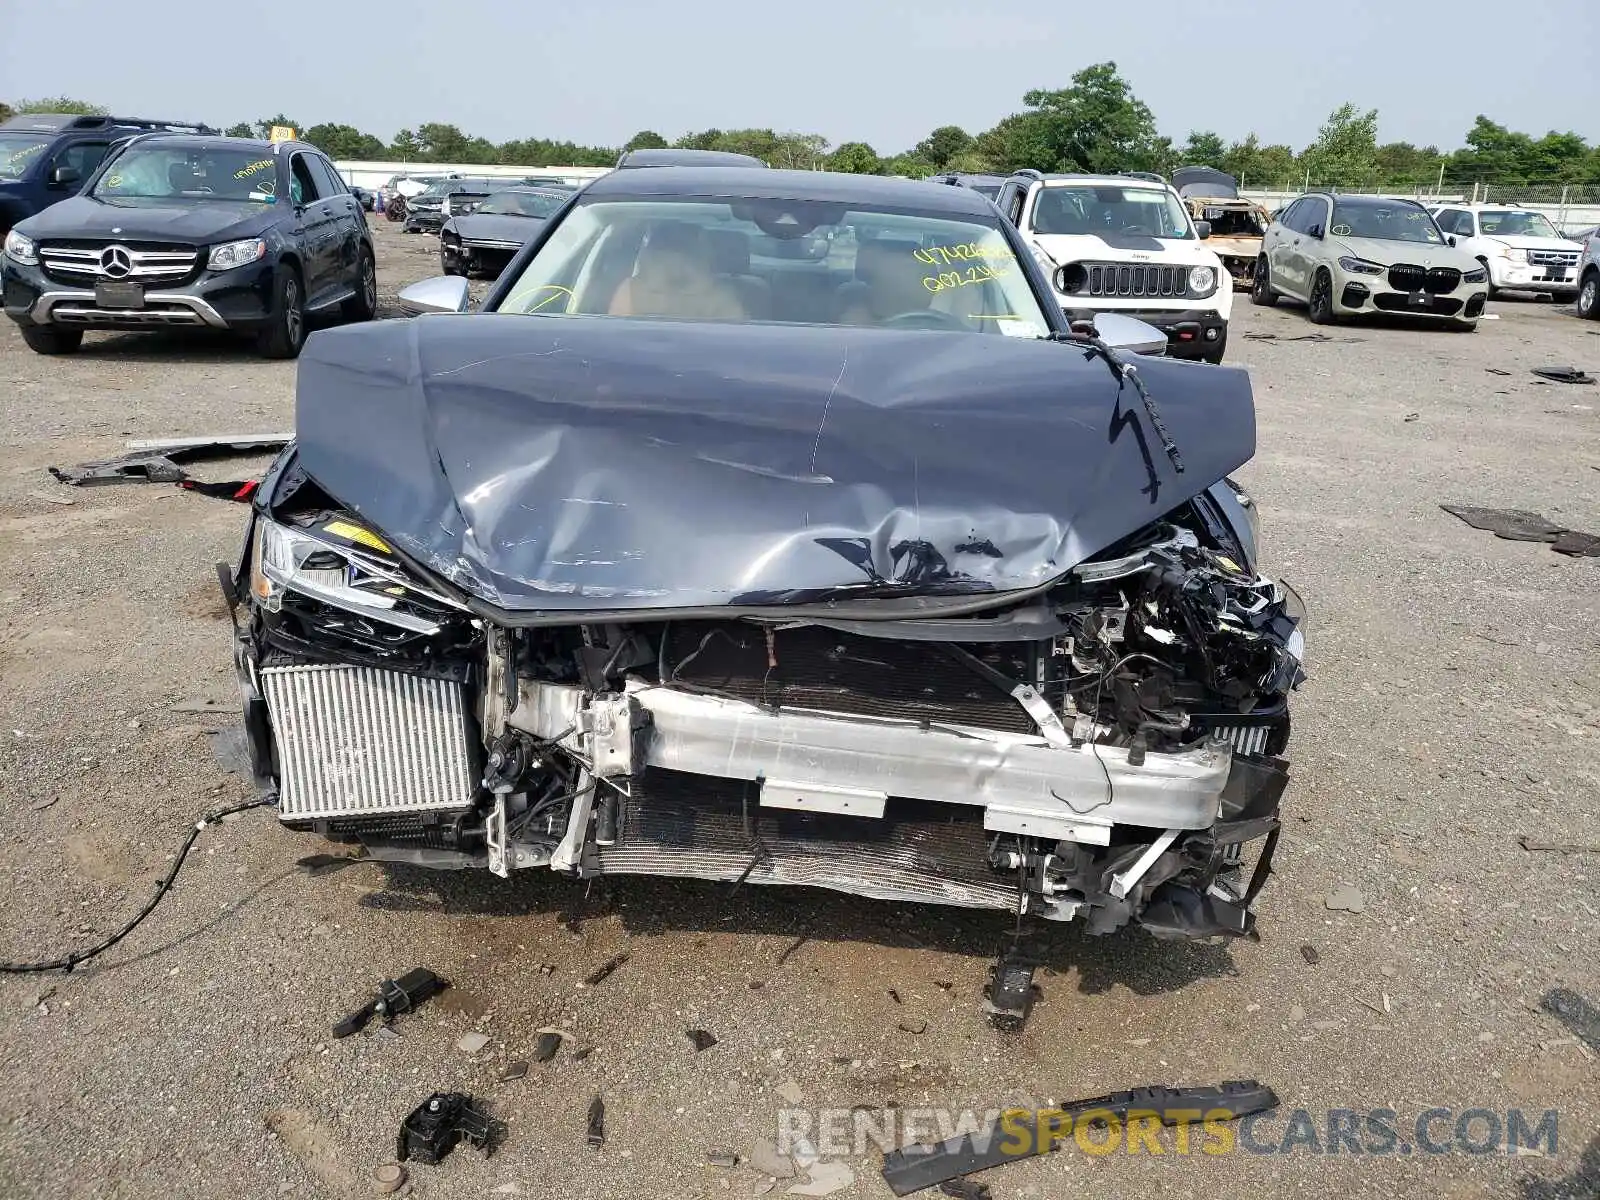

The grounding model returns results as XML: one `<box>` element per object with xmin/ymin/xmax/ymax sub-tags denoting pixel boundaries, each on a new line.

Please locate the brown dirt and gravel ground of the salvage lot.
<box><xmin>0</xmin><ymin>226</ymin><xmax>1600</xmax><ymax>1200</ymax></box>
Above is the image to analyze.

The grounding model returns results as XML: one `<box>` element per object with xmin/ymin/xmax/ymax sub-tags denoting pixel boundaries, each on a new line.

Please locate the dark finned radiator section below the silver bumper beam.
<box><xmin>595</xmin><ymin>768</ymin><xmax>1016</xmax><ymax>909</ymax></box>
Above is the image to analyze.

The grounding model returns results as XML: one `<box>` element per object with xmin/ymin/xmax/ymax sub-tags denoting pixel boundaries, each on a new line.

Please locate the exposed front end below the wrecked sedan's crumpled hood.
<box><xmin>222</xmin><ymin>466</ymin><xmax>1302</xmax><ymax>938</ymax></box>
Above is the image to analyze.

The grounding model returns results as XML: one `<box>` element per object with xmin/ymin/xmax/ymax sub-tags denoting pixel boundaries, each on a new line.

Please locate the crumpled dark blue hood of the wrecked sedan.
<box><xmin>296</xmin><ymin>314</ymin><xmax>1256</xmax><ymax>613</ymax></box>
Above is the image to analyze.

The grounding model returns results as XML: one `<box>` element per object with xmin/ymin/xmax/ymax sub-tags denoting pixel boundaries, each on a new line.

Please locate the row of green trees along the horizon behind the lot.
<box><xmin>9</xmin><ymin>62</ymin><xmax>1600</xmax><ymax>190</ymax></box>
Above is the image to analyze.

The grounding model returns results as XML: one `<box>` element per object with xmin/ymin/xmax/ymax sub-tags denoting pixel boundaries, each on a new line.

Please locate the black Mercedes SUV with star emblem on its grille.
<box><xmin>0</xmin><ymin>133</ymin><xmax>378</xmax><ymax>358</ymax></box>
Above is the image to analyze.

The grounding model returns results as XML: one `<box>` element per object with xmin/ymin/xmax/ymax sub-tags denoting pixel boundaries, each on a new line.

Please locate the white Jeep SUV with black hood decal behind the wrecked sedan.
<box><xmin>995</xmin><ymin>171</ymin><xmax>1234</xmax><ymax>363</ymax></box>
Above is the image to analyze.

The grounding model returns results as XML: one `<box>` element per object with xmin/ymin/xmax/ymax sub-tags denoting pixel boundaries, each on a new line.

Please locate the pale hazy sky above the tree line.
<box><xmin>0</xmin><ymin>0</ymin><xmax>1600</xmax><ymax>154</ymax></box>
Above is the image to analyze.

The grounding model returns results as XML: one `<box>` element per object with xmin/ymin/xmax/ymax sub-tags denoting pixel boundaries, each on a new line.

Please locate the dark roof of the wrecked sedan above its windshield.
<box><xmin>584</xmin><ymin>166</ymin><xmax>994</xmax><ymax>218</ymax></box>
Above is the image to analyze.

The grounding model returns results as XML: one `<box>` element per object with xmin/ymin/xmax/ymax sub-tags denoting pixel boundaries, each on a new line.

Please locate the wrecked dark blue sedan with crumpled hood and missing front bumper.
<box><xmin>222</xmin><ymin>168</ymin><xmax>1302</xmax><ymax>998</ymax></box>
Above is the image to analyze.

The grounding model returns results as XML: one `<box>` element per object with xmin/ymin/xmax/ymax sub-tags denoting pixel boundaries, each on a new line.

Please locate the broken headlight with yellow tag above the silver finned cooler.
<box><xmin>250</xmin><ymin>518</ymin><xmax>459</xmax><ymax>635</ymax></box>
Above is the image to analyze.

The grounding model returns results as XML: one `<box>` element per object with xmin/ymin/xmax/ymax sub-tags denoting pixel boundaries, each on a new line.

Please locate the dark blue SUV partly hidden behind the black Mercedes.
<box><xmin>0</xmin><ymin>112</ymin><xmax>216</xmax><ymax>235</ymax></box>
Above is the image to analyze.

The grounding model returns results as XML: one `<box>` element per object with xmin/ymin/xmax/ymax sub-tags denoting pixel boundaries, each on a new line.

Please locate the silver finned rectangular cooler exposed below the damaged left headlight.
<box><xmin>261</xmin><ymin>664</ymin><xmax>474</xmax><ymax>821</ymax></box>
